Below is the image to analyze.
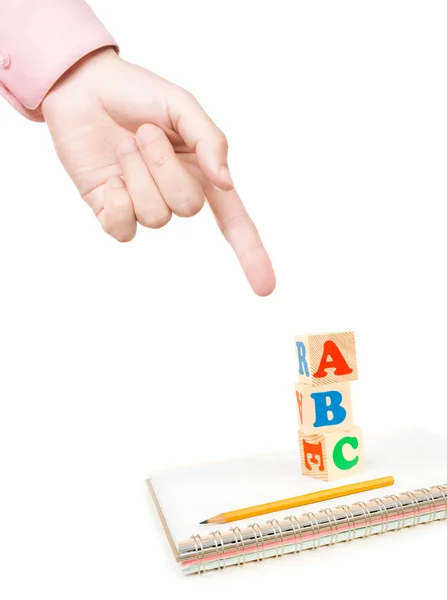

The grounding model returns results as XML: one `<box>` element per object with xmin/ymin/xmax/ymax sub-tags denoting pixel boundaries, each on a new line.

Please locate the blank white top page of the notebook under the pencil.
<box><xmin>151</xmin><ymin>430</ymin><xmax>447</xmax><ymax>546</ymax></box>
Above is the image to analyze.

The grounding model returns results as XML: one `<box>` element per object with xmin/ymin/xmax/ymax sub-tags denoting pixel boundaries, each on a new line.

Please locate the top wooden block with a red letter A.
<box><xmin>295</xmin><ymin>331</ymin><xmax>358</xmax><ymax>385</ymax></box>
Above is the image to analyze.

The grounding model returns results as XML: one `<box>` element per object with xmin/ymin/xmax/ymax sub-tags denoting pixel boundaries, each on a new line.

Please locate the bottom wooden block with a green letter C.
<box><xmin>298</xmin><ymin>427</ymin><xmax>365</xmax><ymax>481</ymax></box>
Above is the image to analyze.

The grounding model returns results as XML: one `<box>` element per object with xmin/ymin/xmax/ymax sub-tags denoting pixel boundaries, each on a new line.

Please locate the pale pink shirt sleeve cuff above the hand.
<box><xmin>0</xmin><ymin>0</ymin><xmax>117</xmax><ymax>121</ymax></box>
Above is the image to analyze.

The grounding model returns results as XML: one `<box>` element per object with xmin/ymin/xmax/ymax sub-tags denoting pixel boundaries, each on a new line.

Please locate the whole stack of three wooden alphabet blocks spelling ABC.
<box><xmin>295</xmin><ymin>332</ymin><xmax>365</xmax><ymax>481</ymax></box>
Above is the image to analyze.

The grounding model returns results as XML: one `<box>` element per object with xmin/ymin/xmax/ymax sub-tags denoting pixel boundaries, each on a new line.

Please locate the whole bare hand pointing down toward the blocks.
<box><xmin>42</xmin><ymin>48</ymin><xmax>275</xmax><ymax>296</ymax></box>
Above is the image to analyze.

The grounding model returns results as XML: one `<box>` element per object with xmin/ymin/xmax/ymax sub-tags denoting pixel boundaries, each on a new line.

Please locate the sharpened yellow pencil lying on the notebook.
<box><xmin>200</xmin><ymin>477</ymin><xmax>394</xmax><ymax>525</ymax></box>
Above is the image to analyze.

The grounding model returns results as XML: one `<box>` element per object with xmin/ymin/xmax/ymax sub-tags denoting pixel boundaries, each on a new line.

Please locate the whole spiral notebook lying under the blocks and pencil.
<box><xmin>148</xmin><ymin>431</ymin><xmax>447</xmax><ymax>574</ymax></box>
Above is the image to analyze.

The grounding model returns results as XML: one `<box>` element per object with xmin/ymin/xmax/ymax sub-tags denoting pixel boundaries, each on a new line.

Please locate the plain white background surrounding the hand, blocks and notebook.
<box><xmin>0</xmin><ymin>0</ymin><xmax>447</xmax><ymax>600</ymax></box>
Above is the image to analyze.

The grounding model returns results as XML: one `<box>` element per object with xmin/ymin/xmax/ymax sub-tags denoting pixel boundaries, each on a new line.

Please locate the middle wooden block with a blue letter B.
<box><xmin>295</xmin><ymin>381</ymin><xmax>353</xmax><ymax>434</ymax></box>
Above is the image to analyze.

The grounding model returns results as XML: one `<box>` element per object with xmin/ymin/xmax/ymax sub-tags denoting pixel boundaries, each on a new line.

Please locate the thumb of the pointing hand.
<box><xmin>168</xmin><ymin>88</ymin><xmax>234</xmax><ymax>191</ymax></box>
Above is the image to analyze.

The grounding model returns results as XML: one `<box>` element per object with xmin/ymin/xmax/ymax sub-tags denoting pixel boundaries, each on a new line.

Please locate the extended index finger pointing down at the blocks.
<box><xmin>205</xmin><ymin>184</ymin><xmax>276</xmax><ymax>296</ymax></box>
